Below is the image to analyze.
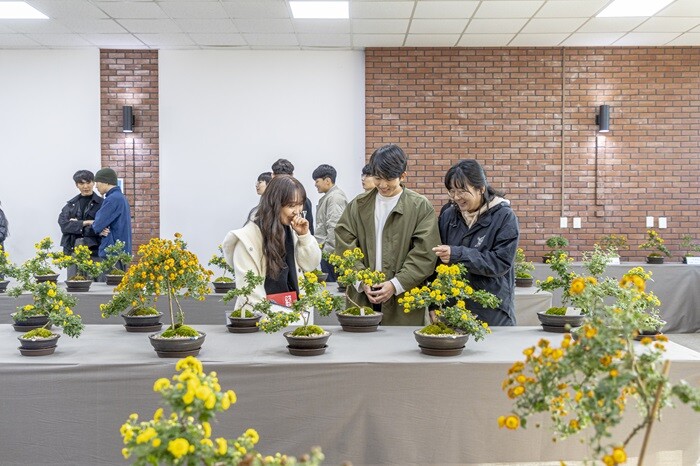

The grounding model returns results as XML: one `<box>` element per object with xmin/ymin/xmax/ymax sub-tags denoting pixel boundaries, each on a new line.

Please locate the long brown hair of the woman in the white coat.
<box><xmin>254</xmin><ymin>175</ymin><xmax>306</xmax><ymax>277</ymax></box>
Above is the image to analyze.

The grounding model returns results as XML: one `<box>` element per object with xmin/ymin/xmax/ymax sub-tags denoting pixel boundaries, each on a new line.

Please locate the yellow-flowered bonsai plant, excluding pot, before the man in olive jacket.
<box><xmin>327</xmin><ymin>248</ymin><xmax>386</xmax><ymax>316</ymax></box>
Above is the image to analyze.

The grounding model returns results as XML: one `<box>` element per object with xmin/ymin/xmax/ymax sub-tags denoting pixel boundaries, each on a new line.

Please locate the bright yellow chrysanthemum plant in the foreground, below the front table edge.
<box><xmin>119</xmin><ymin>356</ymin><xmax>324</xmax><ymax>466</ymax></box>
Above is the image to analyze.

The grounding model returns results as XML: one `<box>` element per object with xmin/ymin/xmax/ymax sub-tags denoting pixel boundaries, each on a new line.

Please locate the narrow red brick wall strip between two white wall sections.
<box><xmin>100</xmin><ymin>50</ymin><xmax>160</xmax><ymax>254</ymax></box>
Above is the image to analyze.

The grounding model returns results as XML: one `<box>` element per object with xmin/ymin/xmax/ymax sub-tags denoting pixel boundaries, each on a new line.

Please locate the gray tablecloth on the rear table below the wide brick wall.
<box><xmin>533</xmin><ymin>262</ymin><xmax>700</xmax><ymax>333</ymax></box>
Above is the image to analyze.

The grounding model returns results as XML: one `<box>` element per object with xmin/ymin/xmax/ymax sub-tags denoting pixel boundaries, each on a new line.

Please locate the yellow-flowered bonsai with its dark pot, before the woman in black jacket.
<box><xmin>399</xmin><ymin>264</ymin><xmax>500</xmax><ymax>356</ymax></box>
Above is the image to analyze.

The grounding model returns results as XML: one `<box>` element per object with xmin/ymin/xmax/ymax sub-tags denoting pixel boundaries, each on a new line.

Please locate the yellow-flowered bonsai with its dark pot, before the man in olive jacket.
<box><xmin>328</xmin><ymin>248</ymin><xmax>386</xmax><ymax>332</ymax></box>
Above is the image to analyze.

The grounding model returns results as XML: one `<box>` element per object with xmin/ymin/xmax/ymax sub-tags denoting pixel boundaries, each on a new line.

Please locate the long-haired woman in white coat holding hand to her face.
<box><xmin>222</xmin><ymin>175</ymin><xmax>321</xmax><ymax>308</ymax></box>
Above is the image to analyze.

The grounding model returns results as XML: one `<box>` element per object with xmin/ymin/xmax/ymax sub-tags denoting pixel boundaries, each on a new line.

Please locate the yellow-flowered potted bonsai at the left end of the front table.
<box><xmin>9</xmin><ymin>281</ymin><xmax>84</xmax><ymax>356</ymax></box>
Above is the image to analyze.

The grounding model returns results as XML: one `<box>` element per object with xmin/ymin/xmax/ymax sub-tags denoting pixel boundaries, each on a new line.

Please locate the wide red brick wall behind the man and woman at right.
<box><xmin>365</xmin><ymin>47</ymin><xmax>700</xmax><ymax>261</ymax></box>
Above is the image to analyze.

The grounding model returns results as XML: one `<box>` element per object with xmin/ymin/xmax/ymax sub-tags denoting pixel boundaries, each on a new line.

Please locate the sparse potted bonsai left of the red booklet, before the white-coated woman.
<box><xmin>221</xmin><ymin>270</ymin><xmax>272</xmax><ymax>333</ymax></box>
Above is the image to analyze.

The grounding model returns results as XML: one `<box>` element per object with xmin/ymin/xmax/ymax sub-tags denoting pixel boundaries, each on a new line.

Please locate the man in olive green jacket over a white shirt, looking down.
<box><xmin>335</xmin><ymin>145</ymin><xmax>440</xmax><ymax>325</ymax></box>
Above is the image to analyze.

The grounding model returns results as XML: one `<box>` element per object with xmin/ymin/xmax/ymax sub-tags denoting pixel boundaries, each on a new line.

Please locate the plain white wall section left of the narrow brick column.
<box><xmin>0</xmin><ymin>50</ymin><xmax>100</xmax><ymax>276</ymax></box>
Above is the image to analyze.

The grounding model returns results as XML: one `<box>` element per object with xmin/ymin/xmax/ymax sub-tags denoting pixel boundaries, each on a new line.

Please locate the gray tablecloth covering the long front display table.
<box><xmin>0</xmin><ymin>325</ymin><xmax>700</xmax><ymax>466</ymax></box>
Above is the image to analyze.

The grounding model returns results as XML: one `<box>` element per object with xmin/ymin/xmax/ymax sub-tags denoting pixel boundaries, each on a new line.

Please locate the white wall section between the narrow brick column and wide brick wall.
<box><xmin>159</xmin><ymin>50</ymin><xmax>364</xmax><ymax>264</ymax></box>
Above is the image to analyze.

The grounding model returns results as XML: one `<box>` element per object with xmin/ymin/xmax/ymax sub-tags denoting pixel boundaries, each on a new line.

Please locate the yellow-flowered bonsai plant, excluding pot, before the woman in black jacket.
<box><xmin>399</xmin><ymin>264</ymin><xmax>501</xmax><ymax>341</ymax></box>
